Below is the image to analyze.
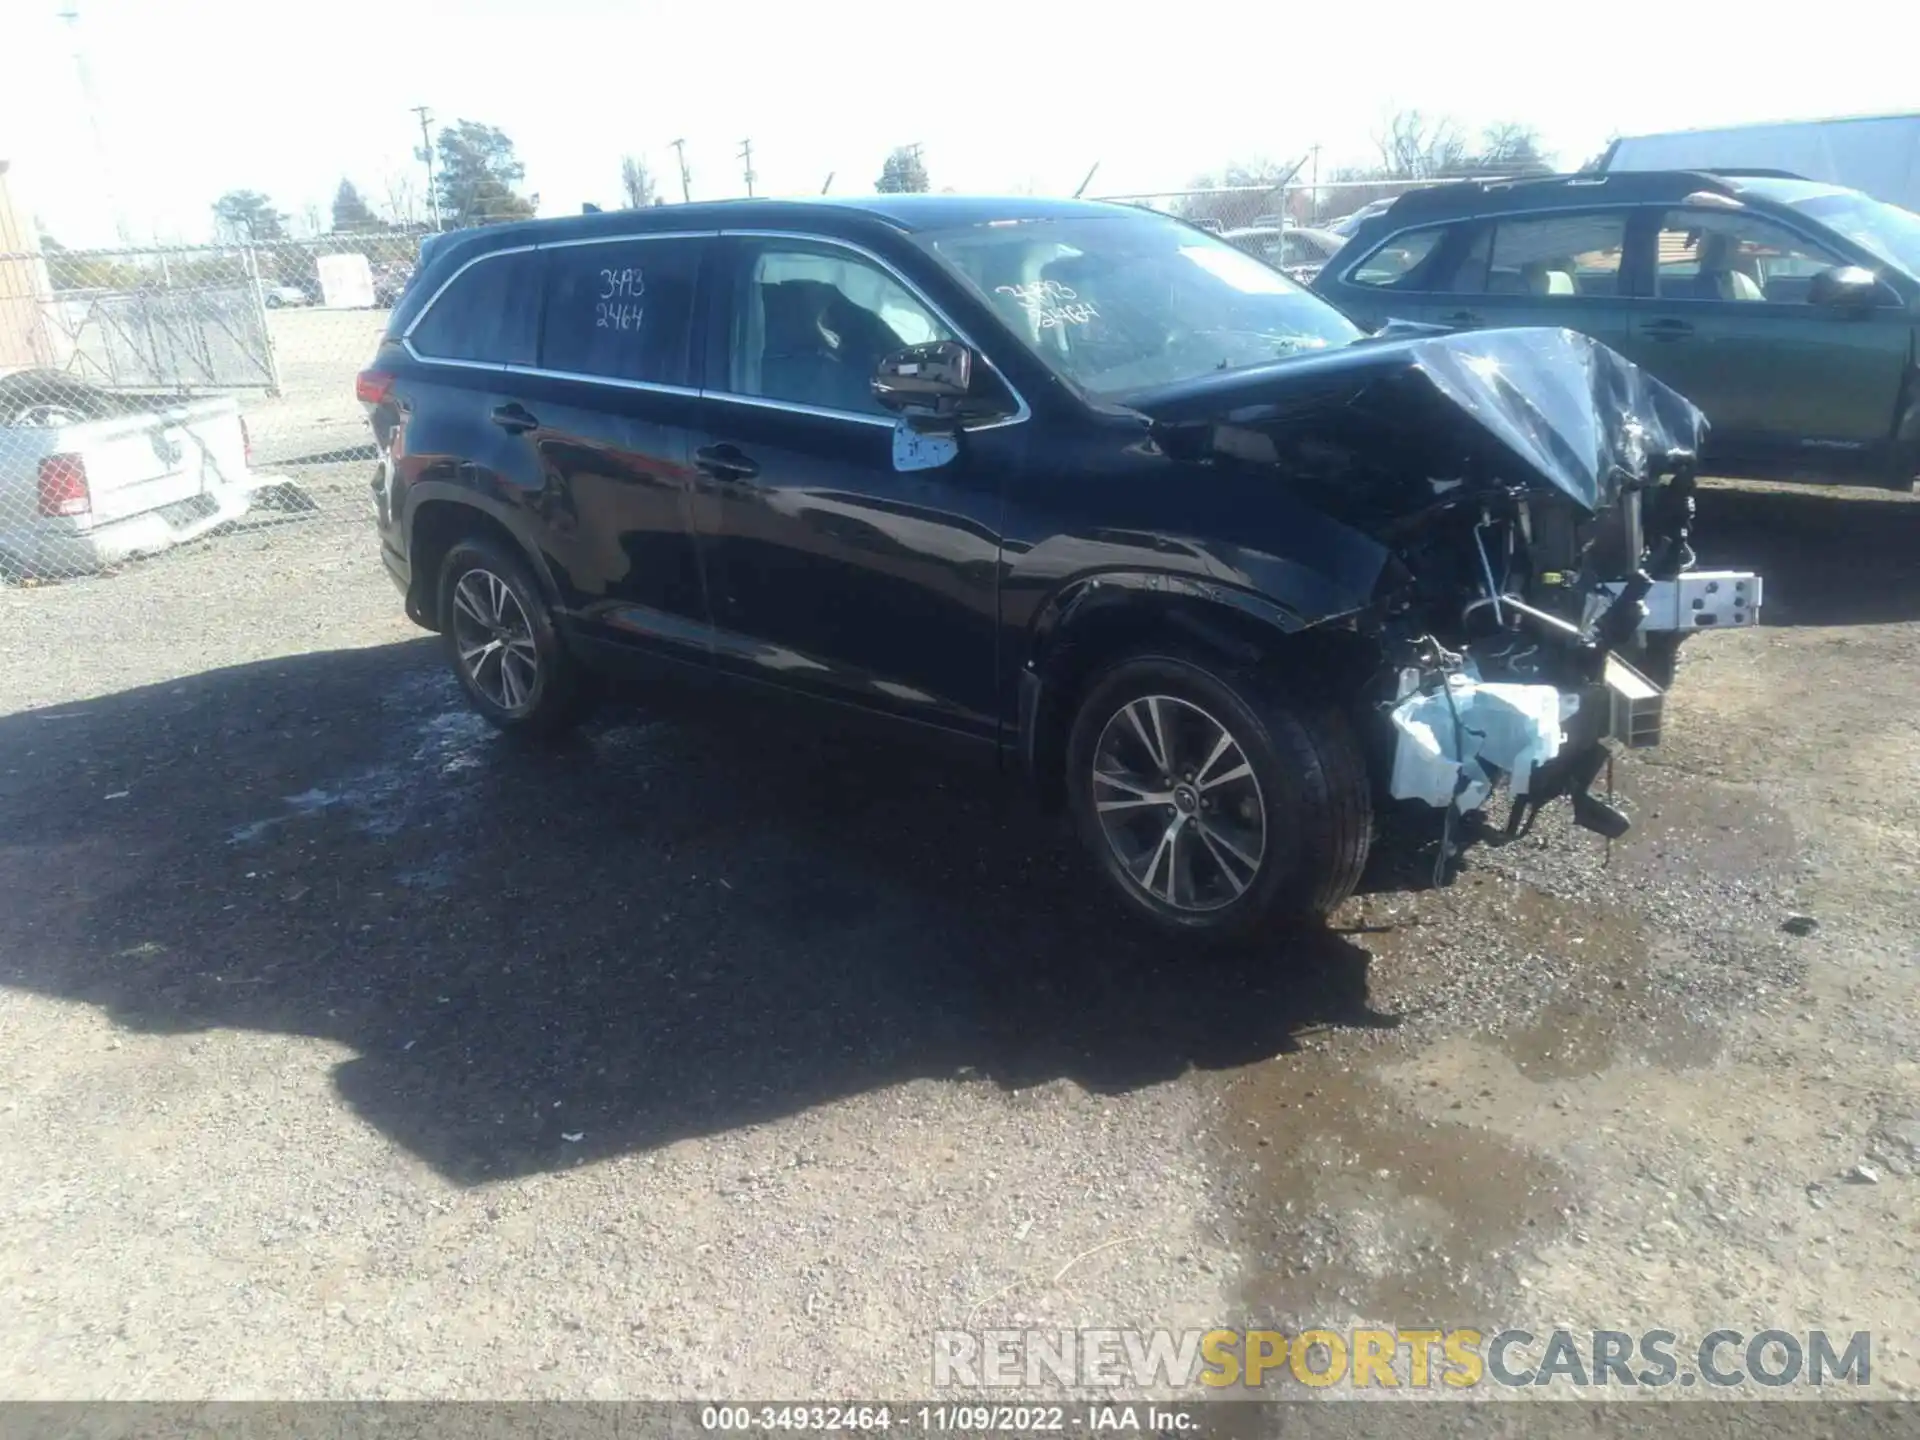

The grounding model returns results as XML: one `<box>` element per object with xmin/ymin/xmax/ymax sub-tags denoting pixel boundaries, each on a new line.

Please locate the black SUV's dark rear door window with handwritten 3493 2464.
<box><xmin>540</xmin><ymin>236</ymin><xmax>705</xmax><ymax>386</ymax></box>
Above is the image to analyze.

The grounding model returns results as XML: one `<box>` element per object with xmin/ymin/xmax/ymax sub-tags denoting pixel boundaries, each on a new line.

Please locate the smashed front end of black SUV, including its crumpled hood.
<box><xmin>1135</xmin><ymin>326</ymin><xmax>1761</xmax><ymax>864</ymax></box>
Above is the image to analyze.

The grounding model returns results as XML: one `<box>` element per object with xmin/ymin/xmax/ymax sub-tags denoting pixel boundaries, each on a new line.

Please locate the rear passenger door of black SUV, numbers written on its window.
<box><xmin>510</xmin><ymin>232</ymin><xmax>710</xmax><ymax>662</ymax></box>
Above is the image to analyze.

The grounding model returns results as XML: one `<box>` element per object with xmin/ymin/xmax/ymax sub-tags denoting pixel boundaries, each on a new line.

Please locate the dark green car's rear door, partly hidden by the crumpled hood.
<box><xmin>1430</xmin><ymin>209</ymin><xmax>1626</xmax><ymax>348</ymax></box>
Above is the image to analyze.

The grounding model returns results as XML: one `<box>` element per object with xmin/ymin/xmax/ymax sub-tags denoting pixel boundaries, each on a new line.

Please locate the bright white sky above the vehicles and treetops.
<box><xmin>0</xmin><ymin>0</ymin><xmax>1920</xmax><ymax>244</ymax></box>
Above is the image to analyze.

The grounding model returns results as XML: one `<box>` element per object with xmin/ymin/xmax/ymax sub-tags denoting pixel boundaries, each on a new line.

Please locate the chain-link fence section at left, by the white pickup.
<box><xmin>0</xmin><ymin>234</ymin><xmax>419</xmax><ymax>586</ymax></box>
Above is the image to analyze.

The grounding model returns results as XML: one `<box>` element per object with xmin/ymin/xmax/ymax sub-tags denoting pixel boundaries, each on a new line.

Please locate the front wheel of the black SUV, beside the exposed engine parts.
<box><xmin>1068</xmin><ymin>653</ymin><xmax>1373</xmax><ymax>939</ymax></box>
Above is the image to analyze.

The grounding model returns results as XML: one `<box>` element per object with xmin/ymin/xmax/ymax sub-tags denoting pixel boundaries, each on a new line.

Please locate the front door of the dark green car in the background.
<box><xmin>1620</xmin><ymin>205</ymin><xmax>1912</xmax><ymax>468</ymax></box>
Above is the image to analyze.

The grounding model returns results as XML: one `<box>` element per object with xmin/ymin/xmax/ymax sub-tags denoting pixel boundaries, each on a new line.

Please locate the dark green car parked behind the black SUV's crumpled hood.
<box><xmin>1315</xmin><ymin>171</ymin><xmax>1920</xmax><ymax>486</ymax></box>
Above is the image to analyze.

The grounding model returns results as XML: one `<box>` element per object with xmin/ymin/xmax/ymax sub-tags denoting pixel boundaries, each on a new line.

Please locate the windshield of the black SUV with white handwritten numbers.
<box><xmin>920</xmin><ymin>211</ymin><xmax>1361</xmax><ymax>397</ymax></box>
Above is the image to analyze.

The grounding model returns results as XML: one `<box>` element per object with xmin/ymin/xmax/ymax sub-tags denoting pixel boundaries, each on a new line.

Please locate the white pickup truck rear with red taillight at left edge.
<box><xmin>0</xmin><ymin>371</ymin><xmax>278</xmax><ymax>580</ymax></box>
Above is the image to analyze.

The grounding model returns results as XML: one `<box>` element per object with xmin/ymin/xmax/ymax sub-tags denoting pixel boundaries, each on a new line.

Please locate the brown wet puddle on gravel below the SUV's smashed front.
<box><xmin>1217</xmin><ymin>872</ymin><xmax>1743</xmax><ymax>1329</ymax></box>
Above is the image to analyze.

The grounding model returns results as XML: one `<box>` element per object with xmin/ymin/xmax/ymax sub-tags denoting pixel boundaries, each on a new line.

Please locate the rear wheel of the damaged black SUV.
<box><xmin>440</xmin><ymin>538</ymin><xmax>591</xmax><ymax>739</ymax></box>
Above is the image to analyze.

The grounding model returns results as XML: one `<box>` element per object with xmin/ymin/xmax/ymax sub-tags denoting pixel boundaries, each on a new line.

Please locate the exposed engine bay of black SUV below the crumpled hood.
<box><xmin>1380</xmin><ymin>457</ymin><xmax>1735</xmax><ymax>852</ymax></box>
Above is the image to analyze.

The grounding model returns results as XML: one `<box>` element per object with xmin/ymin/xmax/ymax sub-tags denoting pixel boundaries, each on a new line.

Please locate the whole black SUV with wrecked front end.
<box><xmin>359</xmin><ymin>196</ymin><xmax>1759</xmax><ymax>933</ymax></box>
